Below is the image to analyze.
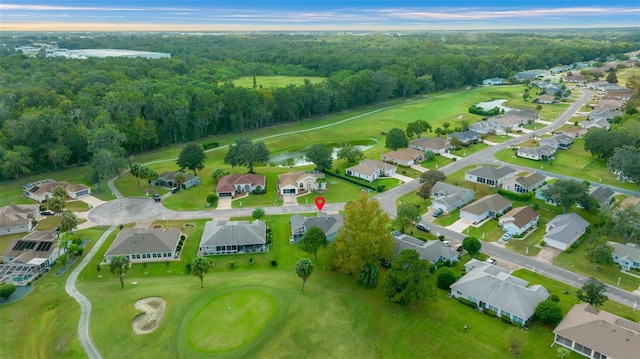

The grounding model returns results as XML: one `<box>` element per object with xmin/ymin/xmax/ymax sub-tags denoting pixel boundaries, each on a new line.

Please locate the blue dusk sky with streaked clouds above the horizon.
<box><xmin>0</xmin><ymin>0</ymin><xmax>640</xmax><ymax>31</ymax></box>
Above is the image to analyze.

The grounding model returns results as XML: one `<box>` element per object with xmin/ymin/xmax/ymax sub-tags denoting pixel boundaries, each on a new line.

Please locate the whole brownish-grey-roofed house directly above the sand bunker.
<box><xmin>104</xmin><ymin>228</ymin><xmax>182</xmax><ymax>263</ymax></box>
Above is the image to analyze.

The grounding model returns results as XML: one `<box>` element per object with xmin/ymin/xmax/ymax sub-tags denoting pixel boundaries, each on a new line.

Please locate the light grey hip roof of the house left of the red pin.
<box><xmin>200</xmin><ymin>220</ymin><xmax>267</xmax><ymax>247</ymax></box>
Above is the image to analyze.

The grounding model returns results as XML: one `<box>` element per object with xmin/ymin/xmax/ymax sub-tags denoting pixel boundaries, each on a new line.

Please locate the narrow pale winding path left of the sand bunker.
<box><xmin>64</xmin><ymin>226</ymin><xmax>116</xmax><ymax>359</ymax></box>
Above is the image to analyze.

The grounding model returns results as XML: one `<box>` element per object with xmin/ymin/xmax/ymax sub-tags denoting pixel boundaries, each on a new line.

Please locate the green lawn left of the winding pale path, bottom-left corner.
<box><xmin>0</xmin><ymin>228</ymin><xmax>106</xmax><ymax>359</ymax></box>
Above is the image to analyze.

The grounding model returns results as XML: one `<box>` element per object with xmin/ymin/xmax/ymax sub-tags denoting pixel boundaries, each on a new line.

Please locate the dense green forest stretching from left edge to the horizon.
<box><xmin>0</xmin><ymin>29</ymin><xmax>640</xmax><ymax>183</ymax></box>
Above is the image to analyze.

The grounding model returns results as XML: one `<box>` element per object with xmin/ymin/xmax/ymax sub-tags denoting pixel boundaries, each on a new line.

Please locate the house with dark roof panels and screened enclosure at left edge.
<box><xmin>0</xmin><ymin>231</ymin><xmax>61</xmax><ymax>286</ymax></box>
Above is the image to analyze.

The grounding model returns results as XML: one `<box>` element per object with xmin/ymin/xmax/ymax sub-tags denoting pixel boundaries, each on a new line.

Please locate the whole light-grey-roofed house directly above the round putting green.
<box><xmin>198</xmin><ymin>220</ymin><xmax>269</xmax><ymax>256</ymax></box>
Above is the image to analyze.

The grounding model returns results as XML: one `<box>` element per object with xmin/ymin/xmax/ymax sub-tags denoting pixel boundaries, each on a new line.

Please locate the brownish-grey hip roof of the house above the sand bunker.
<box><xmin>106</xmin><ymin>228</ymin><xmax>182</xmax><ymax>256</ymax></box>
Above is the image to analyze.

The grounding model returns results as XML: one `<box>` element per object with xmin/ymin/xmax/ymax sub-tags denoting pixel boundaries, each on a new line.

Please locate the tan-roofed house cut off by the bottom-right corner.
<box><xmin>553</xmin><ymin>303</ymin><xmax>640</xmax><ymax>359</ymax></box>
